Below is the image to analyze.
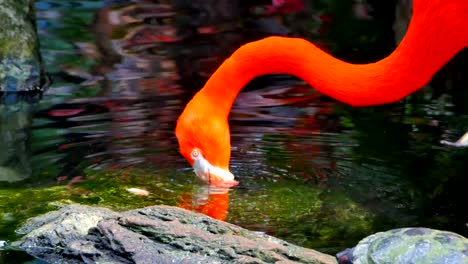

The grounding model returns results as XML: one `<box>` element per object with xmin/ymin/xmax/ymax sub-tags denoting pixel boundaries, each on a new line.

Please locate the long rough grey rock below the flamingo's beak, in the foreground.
<box><xmin>13</xmin><ymin>205</ymin><xmax>336</xmax><ymax>263</ymax></box>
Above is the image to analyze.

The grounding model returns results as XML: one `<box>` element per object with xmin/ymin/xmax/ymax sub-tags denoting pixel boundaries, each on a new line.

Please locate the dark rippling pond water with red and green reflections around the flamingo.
<box><xmin>0</xmin><ymin>0</ymin><xmax>468</xmax><ymax>263</ymax></box>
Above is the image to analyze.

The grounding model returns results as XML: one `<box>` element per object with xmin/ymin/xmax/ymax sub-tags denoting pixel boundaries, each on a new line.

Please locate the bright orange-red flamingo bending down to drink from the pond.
<box><xmin>175</xmin><ymin>0</ymin><xmax>468</xmax><ymax>188</ymax></box>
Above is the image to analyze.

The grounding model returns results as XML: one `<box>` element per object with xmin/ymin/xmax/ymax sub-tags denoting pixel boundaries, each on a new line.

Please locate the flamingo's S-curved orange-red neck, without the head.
<box><xmin>194</xmin><ymin>0</ymin><xmax>468</xmax><ymax>117</ymax></box>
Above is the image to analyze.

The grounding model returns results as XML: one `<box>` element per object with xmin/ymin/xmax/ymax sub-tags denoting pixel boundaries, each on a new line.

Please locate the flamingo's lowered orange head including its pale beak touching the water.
<box><xmin>175</xmin><ymin>97</ymin><xmax>237</xmax><ymax>188</ymax></box>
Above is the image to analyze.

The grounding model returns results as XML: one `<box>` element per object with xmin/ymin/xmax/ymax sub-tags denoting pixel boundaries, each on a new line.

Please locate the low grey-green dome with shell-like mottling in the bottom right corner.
<box><xmin>337</xmin><ymin>227</ymin><xmax>468</xmax><ymax>264</ymax></box>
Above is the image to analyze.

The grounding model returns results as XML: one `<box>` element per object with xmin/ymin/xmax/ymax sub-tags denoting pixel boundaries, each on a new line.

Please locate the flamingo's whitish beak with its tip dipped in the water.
<box><xmin>192</xmin><ymin>153</ymin><xmax>238</xmax><ymax>188</ymax></box>
